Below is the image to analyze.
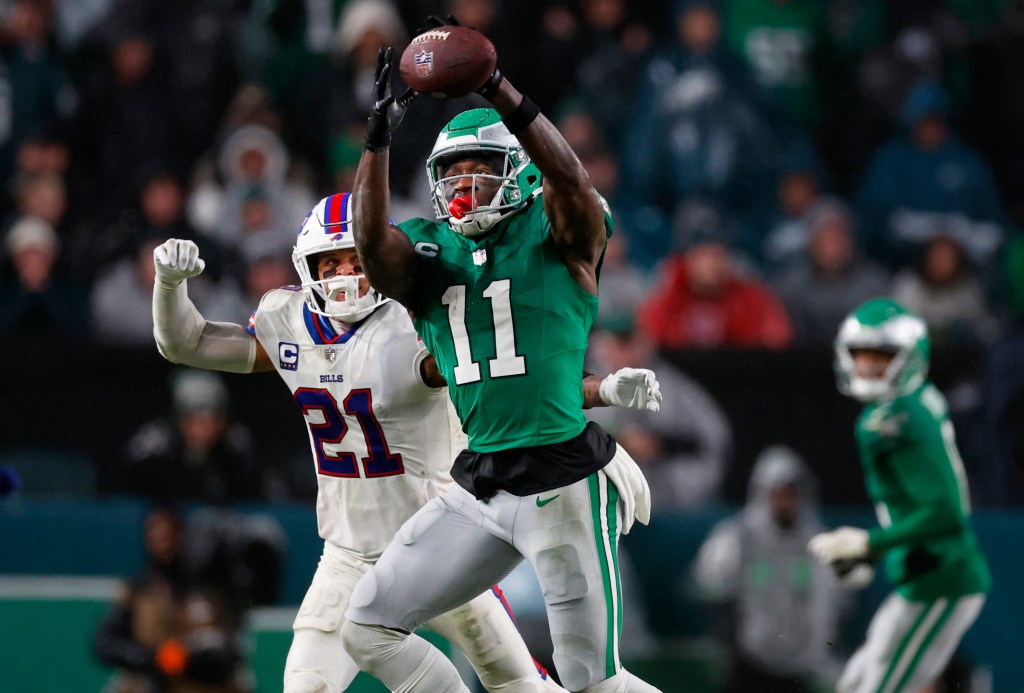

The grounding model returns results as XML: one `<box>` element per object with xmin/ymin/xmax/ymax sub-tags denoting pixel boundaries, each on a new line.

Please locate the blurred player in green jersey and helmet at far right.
<box><xmin>809</xmin><ymin>299</ymin><xmax>991</xmax><ymax>693</ymax></box>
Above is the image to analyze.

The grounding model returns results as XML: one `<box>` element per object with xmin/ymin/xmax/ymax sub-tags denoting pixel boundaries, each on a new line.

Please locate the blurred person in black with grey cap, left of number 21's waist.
<box><xmin>99</xmin><ymin>370</ymin><xmax>284</xmax><ymax>505</ymax></box>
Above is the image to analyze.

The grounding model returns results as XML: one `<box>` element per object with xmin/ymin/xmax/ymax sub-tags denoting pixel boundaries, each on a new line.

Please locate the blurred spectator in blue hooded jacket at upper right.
<box><xmin>856</xmin><ymin>79</ymin><xmax>1004</xmax><ymax>266</ymax></box>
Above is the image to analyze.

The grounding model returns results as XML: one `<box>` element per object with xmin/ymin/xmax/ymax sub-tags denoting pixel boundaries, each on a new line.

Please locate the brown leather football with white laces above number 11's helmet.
<box><xmin>398</xmin><ymin>26</ymin><xmax>498</xmax><ymax>98</ymax></box>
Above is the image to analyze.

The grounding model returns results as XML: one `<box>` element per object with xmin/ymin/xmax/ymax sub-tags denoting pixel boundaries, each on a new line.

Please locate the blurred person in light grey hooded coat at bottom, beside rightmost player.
<box><xmin>692</xmin><ymin>445</ymin><xmax>842</xmax><ymax>693</ymax></box>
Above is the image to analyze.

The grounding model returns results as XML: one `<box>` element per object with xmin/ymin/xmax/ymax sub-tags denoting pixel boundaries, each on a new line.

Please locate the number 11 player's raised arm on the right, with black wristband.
<box><xmin>480</xmin><ymin>65</ymin><xmax>605</xmax><ymax>295</ymax></box>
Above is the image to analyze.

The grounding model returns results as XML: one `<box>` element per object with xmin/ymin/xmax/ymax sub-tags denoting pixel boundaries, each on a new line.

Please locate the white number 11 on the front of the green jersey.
<box><xmin>441</xmin><ymin>279</ymin><xmax>526</xmax><ymax>385</ymax></box>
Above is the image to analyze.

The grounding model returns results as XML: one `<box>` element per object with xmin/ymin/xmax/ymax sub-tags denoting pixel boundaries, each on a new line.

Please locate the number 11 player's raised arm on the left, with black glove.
<box><xmin>352</xmin><ymin>48</ymin><xmax>417</xmax><ymax>308</ymax></box>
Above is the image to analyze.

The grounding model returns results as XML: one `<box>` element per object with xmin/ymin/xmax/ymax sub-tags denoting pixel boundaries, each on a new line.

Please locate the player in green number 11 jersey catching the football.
<box><xmin>342</xmin><ymin>15</ymin><xmax>656</xmax><ymax>693</ymax></box>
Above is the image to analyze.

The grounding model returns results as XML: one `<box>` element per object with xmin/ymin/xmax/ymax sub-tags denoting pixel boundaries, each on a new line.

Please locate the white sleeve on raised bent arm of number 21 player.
<box><xmin>153</xmin><ymin>280</ymin><xmax>256</xmax><ymax>373</ymax></box>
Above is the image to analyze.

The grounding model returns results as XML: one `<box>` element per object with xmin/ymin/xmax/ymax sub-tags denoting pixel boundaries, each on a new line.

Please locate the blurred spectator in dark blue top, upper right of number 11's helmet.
<box><xmin>620</xmin><ymin>2</ymin><xmax>783</xmax><ymax>266</ymax></box>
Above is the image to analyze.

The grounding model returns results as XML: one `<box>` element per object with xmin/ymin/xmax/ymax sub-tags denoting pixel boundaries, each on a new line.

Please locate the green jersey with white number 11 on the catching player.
<box><xmin>400</xmin><ymin>194</ymin><xmax>611</xmax><ymax>452</ymax></box>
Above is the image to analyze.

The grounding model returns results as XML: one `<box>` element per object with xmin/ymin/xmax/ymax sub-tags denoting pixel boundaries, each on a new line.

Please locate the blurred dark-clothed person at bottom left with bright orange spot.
<box><xmin>93</xmin><ymin>508</ymin><xmax>250</xmax><ymax>693</ymax></box>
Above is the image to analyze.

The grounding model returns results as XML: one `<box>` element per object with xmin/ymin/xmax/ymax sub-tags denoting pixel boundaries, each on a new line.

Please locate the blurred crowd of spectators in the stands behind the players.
<box><xmin>0</xmin><ymin>0</ymin><xmax>1024</xmax><ymax>690</ymax></box>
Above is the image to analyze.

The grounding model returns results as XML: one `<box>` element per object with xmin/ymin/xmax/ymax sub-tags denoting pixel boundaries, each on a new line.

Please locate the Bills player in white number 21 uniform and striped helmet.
<box><xmin>154</xmin><ymin>193</ymin><xmax>649</xmax><ymax>693</ymax></box>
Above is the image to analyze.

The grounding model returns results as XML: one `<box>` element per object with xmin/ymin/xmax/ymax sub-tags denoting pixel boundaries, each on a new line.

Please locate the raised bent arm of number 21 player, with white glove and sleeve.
<box><xmin>153</xmin><ymin>239</ymin><xmax>273</xmax><ymax>373</ymax></box>
